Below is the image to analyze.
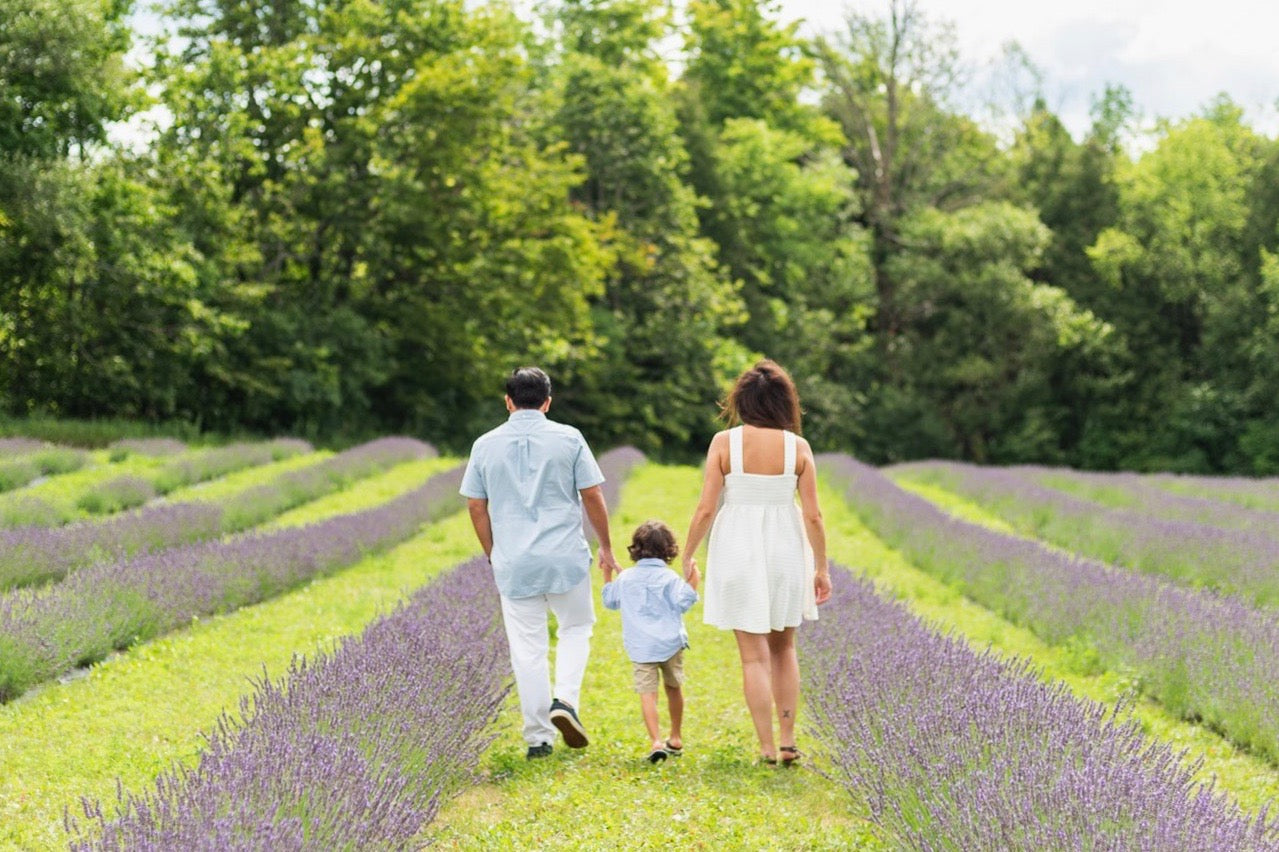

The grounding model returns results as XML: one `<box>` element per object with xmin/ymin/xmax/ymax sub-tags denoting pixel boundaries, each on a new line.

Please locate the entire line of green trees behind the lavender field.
<box><xmin>0</xmin><ymin>0</ymin><xmax>1279</xmax><ymax>475</ymax></box>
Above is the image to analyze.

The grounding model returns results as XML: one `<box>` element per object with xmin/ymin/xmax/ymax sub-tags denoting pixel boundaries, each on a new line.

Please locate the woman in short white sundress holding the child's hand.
<box><xmin>683</xmin><ymin>359</ymin><xmax>830</xmax><ymax>766</ymax></box>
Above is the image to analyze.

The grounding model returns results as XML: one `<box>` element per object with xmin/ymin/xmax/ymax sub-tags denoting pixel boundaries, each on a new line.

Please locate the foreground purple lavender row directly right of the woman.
<box><xmin>799</xmin><ymin>569</ymin><xmax>1279</xmax><ymax>851</ymax></box>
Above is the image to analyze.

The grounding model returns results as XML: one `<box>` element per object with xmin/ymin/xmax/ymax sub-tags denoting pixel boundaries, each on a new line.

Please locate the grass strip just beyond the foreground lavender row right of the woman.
<box><xmin>821</xmin><ymin>470</ymin><xmax>1279</xmax><ymax>811</ymax></box>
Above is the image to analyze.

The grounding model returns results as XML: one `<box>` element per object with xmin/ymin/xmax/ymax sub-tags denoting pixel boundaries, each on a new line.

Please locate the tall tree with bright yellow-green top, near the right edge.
<box><xmin>1088</xmin><ymin>104</ymin><xmax>1259</xmax><ymax>471</ymax></box>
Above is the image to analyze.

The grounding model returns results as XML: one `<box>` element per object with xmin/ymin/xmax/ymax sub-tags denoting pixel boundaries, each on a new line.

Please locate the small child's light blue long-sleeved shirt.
<box><xmin>602</xmin><ymin>559</ymin><xmax>697</xmax><ymax>663</ymax></box>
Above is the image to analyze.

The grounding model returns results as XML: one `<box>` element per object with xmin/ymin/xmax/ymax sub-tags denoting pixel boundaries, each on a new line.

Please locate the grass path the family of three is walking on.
<box><xmin>428</xmin><ymin>464</ymin><xmax>883</xmax><ymax>849</ymax></box>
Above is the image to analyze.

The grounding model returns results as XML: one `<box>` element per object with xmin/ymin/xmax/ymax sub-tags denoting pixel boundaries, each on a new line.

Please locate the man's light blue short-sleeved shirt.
<box><xmin>459</xmin><ymin>408</ymin><xmax>604</xmax><ymax>597</ymax></box>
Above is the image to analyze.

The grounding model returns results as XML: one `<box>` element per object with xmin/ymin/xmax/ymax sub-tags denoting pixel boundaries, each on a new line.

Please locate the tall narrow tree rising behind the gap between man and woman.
<box><xmin>551</xmin><ymin>0</ymin><xmax>746</xmax><ymax>454</ymax></box>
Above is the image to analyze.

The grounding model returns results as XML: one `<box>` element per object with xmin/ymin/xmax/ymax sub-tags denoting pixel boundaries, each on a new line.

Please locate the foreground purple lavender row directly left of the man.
<box><xmin>68</xmin><ymin>560</ymin><xmax>510</xmax><ymax>852</ymax></box>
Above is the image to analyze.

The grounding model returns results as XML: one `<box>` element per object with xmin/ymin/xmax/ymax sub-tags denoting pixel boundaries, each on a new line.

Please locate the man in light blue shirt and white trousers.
<box><xmin>460</xmin><ymin>367</ymin><xmax>618</xmax><ymax>759</ymax></box>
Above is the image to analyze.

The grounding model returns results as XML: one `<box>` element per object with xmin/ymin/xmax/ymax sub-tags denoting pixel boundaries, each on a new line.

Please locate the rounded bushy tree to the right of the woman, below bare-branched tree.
<box><xmin>869</xmin><ymin>203</ymin><xmax>1111</xmax><ymax>461</ymax></box>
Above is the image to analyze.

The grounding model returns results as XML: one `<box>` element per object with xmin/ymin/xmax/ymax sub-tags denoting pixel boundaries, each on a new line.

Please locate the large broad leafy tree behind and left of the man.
<box><xmin>145</xmin><ymin>0</ymin><xmax>605</xmax><ymax>443</ymax></box>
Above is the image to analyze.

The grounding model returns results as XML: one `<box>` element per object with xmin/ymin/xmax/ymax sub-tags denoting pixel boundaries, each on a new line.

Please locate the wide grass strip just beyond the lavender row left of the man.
<box><xmin>0</xmin><ymin>501</ymin><xmax>477</xmax><ymax>849</ymax></box>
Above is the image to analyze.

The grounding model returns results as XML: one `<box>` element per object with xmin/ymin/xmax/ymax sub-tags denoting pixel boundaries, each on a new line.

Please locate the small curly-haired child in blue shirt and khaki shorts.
<box><xmin>604</xmin><ymin>521</ymin><xmax>697</xmax><ymax>764</ymax></box>
